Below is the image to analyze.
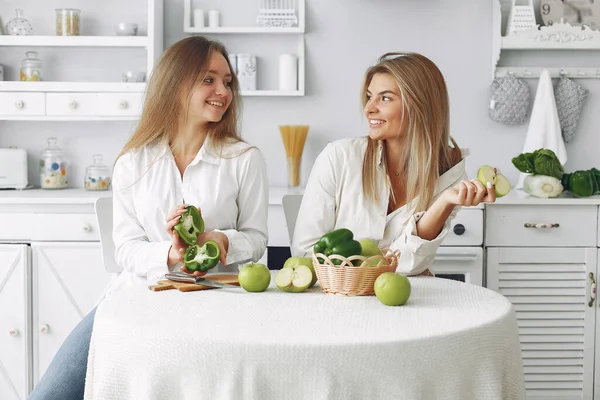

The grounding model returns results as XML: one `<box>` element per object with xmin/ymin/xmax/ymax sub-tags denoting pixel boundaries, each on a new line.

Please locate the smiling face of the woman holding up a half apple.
<box><xmin>365</xmin><ymin>72</ymin><xmax>408</xmax><ymax>140</ymax></box>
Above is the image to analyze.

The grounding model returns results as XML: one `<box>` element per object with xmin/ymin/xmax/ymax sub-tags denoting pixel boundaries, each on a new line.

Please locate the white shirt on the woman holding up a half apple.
<box><xmin>292</xmin><ymin>137</ymin><xmax>467</xmax><ymax>275</ymax></box>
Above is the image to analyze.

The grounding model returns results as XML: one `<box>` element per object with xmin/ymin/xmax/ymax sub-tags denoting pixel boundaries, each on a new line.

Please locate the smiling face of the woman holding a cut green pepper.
<box><xmin>188</xmin><ymin>51</ymin><xmax>233</xmax><ymax>123</ymax></box>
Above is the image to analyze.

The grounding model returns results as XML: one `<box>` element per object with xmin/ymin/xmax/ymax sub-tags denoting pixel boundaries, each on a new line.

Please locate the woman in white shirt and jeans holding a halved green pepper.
<box><xmin>30</xmin><ymin>36</ymin><xmax>268</xmax><ymax>400</ymax></box>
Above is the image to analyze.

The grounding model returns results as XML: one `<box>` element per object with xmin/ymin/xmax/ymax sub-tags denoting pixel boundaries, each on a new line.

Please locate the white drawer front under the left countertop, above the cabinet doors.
<box><xmin>0</xmin><ymin>213</ymin><xmax>100</xmax><ymax>242</ymax></box>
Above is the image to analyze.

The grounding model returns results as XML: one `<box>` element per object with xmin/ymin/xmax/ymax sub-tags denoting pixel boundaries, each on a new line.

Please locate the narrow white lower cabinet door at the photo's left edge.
<box><xmin>0</xmin><ymin>244</ymin><xmax>30</xmax><ymax>400</ymax></box>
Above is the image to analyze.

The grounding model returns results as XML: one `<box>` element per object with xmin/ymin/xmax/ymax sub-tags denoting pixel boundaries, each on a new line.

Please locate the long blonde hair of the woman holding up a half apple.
<box><xmin>362</xmin><ymin>53</ymin><xmax>462</xmax><ymax>211</ymax></box>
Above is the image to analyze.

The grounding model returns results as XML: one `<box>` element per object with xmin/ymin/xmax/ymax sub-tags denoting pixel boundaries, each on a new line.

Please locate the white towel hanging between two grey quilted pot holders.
<box><xmin>516</xmin><ymin>69</ymin><xmax>567</xmax><ymax>189</ymax></box>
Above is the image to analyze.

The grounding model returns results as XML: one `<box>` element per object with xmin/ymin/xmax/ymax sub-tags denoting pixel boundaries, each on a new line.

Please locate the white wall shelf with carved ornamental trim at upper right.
<box><xmin>492</xmin><ymin>0</ymin><xmax>600</xmax><ymax>79</ymax></box>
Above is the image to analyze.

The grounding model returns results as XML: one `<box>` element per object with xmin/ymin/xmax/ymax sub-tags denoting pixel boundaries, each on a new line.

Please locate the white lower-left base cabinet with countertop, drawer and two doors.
<box><xmin>0</xmin><ymin>189</ymin><xmax>112</xmax><ymax>400</ymax></box>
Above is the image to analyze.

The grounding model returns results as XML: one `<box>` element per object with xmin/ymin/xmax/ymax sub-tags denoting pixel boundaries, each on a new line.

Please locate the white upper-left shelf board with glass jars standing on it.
<box><xmin>0</xmin><ymin>35</ymin><xmax>149</xmax><ymax>48</ymax></box>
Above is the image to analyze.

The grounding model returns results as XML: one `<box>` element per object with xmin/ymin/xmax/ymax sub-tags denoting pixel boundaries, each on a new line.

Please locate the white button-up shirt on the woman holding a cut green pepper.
<box><xmin>111</xmin><ymin>138</ymin><xmax>268</xmax><ymax>291</ymax></box>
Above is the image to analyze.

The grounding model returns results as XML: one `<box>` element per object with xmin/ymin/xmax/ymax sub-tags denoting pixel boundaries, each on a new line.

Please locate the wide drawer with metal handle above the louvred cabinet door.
<box><xmin>485</xmin><ymin>205</ymin><xmax>598</xmax><ymax>247</ymax></box>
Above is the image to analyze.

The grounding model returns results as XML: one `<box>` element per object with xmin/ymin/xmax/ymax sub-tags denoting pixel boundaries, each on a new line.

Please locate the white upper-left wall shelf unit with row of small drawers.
<box><xmin>0</xmin><ymin>0</ymin><xmax>164</xmax><ymax>121</ymax></box>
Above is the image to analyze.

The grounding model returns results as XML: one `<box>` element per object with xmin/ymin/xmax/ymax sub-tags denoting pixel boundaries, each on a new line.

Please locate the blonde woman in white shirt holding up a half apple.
<box><xmin>292</xmin><ymin>53</ymin><xmax>495</xmax><ymax>275</ymax></box>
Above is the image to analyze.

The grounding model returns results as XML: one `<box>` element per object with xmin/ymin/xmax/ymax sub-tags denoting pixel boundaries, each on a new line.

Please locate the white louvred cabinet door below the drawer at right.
<box><xmin>487</xmin><ymin>247</ymin><xmax>597</xmax><ymax>400</ymax></box>
